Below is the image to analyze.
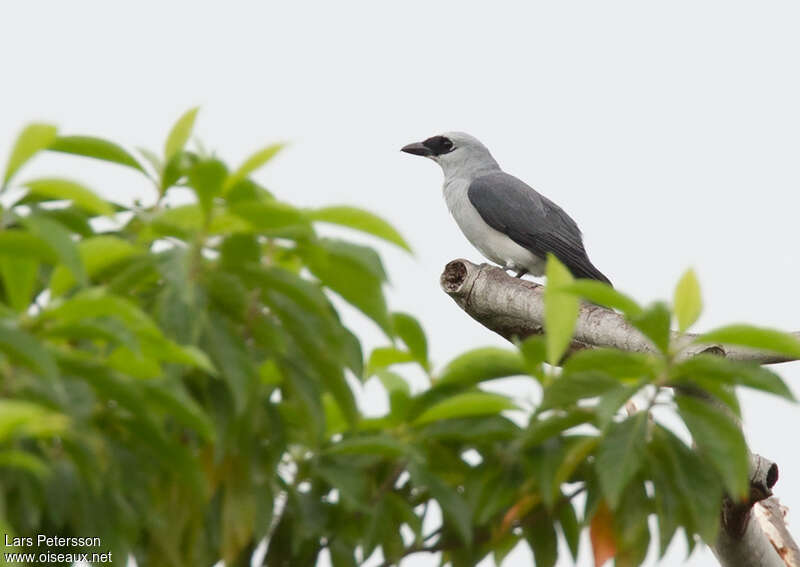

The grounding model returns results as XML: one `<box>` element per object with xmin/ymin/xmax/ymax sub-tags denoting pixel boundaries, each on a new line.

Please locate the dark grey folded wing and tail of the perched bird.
<box><xmin>467</xmin><ymin>172</ymin><xmax>610</xmax><ymax>283</ymax></box>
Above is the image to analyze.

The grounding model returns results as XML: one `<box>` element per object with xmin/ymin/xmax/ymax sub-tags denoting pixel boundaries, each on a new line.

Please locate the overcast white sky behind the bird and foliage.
<box><xmin>0</xmin><ymin>0</ymin><xmax>800</xmax><ymax>567</ymax></box>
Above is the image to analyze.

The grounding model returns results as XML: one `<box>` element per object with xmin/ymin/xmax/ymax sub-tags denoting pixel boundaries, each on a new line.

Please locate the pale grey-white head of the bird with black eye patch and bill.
<box><xmin>401</xmin><ymin>132</ymin><xmax>500</xmax><ymax>179</ymax></box>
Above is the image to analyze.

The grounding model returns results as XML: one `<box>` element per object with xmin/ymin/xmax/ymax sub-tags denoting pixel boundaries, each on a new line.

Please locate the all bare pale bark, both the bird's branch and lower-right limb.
<box><xmin>441</xmin><ymin>259</ymin><xmax>800</xmax><ymax>567</ymax></box>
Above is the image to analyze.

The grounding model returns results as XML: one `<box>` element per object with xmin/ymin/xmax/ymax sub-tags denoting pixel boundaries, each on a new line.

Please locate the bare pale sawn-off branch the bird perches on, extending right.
<box><xmin>440</xmin><ymin>259</ymin><xmax>800</xmax><ymax>364</ymax></box>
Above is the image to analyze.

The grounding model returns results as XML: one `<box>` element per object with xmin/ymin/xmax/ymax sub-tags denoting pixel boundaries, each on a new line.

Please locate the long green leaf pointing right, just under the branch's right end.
<box><xmin>672</xmin><ymin>354</ymin><xmax>795</xmax><ymax>401</ymax></box>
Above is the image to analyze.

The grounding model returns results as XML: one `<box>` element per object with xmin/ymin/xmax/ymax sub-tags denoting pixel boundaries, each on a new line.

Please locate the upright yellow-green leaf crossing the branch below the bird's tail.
<box><xmin>544</xmin><ymin>254</ymin><xmax>580</xmax><ymax>366</ymax></box>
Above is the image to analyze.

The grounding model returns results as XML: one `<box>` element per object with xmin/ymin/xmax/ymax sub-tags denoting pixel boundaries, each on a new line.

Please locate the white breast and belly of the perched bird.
<box><xmin>443</xmin><ymin>178</ymin><xmax>544</xmax><ymax>276</ymax></box>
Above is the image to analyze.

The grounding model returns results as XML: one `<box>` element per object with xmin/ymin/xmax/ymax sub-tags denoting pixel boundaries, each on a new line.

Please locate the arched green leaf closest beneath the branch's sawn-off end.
<box><xmin>436</xmin><ymin>347</ymin><xmax>525</xmax><ymax>386</ymax></box>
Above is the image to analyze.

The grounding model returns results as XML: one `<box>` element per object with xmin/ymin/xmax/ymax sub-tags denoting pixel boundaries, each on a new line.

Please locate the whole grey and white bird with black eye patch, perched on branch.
<box><xmin>402</xmin><ymin>132</ymin><xmax>611</xmax><ymax>284</ymax></box>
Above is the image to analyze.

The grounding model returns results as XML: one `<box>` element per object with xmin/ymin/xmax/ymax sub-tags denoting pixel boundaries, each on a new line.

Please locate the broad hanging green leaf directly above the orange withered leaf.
<box><xmin>596</xmin><ymin>412</ymin><xmax>647</xmax><ymax>510</ymax></box>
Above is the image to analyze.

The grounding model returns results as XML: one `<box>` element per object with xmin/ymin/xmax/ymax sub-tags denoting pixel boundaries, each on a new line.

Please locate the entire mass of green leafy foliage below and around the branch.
<box><xmin>0</xmin><ymin>109</ymin><xmax>800</xmax><ymax>567</ymax></box>
